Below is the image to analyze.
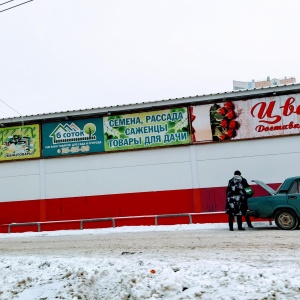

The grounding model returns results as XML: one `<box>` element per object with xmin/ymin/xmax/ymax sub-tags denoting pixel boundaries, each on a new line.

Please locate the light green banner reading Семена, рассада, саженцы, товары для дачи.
<box><xmin>103</xmin><ymin>107</ymin><xmax>190</xmax><ymax>151</ymax></box>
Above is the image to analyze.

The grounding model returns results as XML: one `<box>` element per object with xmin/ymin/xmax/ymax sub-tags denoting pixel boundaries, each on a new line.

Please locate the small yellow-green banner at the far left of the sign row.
<box><xmin>0</xmin><ymin>124</ymin><xmax>41</xmax><ymax>161</ymax></box>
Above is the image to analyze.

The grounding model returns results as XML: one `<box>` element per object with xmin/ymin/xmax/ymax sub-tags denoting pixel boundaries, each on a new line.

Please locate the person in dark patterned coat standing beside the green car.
<box><xmin>226</xmin><ymin>171</ymin><xmax>248</xmax><ymax>231</ymax></box>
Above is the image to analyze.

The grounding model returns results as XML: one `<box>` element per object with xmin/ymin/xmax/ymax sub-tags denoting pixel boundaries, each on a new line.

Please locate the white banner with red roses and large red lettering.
<box><xmin>190</xmin><ymin>94</ymin><xmax>300</xmax><ymax>142</ymax></box>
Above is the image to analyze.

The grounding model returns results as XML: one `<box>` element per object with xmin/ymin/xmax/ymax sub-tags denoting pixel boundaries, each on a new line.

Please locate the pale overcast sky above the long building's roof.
<box><xmin>0</xmin><ymin>0</ymin><xmax>300</xmax><ymax>118</ymax></box>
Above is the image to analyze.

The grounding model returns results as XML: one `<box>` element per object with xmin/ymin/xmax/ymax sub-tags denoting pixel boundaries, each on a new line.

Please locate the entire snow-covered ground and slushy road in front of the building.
<box><xmin>0</xmin><ymin>222</ymin><xmax>300</xmax><ymax>300</ymax></box>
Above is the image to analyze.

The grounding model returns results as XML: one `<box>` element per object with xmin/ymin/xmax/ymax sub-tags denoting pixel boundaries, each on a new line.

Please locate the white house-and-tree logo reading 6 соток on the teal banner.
<box><xmin>49</xmin><ymin>123</ymin><xmax>96</xmax><ymax>144</ymax></box>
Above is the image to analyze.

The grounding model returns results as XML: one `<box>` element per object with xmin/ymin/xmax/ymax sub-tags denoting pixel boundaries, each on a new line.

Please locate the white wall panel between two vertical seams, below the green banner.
<box><xmin>45</xmin><ymin>147</ymin><xmax>192</xmax><ymax>198</ymax></box>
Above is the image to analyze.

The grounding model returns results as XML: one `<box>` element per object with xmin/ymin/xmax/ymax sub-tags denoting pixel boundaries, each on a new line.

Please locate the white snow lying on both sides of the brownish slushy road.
<box><xmin>0</xmin><ymin>225</ymin><xmax>300</xmax><ymax>300</ymax></box>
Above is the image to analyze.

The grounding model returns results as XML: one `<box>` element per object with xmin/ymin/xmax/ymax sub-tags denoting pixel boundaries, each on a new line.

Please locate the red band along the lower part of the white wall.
<box><xmin>0</xmin><ymin>184</ymin><xmax>279</xmax><ymax>226</ymax></box>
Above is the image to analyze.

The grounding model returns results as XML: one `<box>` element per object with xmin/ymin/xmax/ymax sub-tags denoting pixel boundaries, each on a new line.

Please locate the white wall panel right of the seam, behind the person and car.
<box><xmin>194</xmin><ymin>136</ymin><xmax>300</xmax><ymax>187</ymax></box>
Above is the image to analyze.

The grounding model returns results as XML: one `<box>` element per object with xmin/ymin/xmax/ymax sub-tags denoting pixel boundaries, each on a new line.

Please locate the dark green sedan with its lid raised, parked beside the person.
<box><xmin>247</xmin><ymin>176</ymin><xmax>300</xmax><ymax>230</ymax></box>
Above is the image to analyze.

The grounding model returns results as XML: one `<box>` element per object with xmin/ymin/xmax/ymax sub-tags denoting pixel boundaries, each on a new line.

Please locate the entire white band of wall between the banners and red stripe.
<box><xmin>0</xmin><ymin>136</ymin><xmax>300</xmax><ymax>202</ymax></box>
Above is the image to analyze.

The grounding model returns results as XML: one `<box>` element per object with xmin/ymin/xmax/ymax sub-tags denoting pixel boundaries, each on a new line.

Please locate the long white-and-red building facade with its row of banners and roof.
<box><xmin>0</xmin><ymin>84</ymin><xmax>300</xmax><ymax>229</ymax></box>
